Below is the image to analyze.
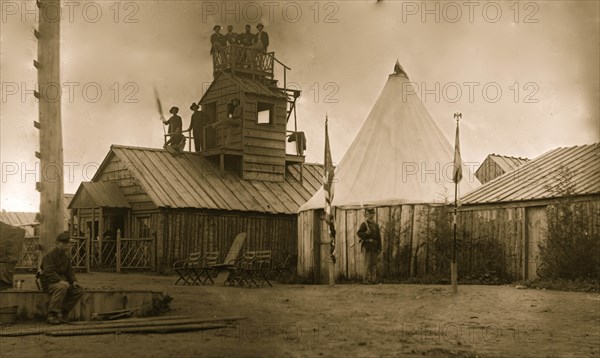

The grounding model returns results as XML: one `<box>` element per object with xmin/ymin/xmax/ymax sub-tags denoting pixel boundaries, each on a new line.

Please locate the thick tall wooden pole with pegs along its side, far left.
<box><xmin>34</xmin><ymin>0</ymin><xmax>64</xmax><ymax>250</ymax></box>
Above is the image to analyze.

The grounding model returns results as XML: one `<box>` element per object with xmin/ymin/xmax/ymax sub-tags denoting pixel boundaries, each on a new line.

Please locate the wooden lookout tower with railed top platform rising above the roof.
<box><xmin>200</xmin><ymin>45</ymin><xmax>304</xmax><ymax>182</ymax></box>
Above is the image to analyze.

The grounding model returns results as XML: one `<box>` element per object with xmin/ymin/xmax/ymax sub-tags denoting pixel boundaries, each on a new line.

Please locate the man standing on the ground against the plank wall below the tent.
<box><xmin>357</xmin><ymin>208</ymin><xmax>381</xmax><ymax>284</ymax></box>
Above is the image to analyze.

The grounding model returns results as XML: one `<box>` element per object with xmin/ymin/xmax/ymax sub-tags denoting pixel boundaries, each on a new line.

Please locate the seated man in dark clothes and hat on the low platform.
<box><xmin>40</xmin><ymin>232</ymin><xmax>83</xmax><ymax>324</ymax></box>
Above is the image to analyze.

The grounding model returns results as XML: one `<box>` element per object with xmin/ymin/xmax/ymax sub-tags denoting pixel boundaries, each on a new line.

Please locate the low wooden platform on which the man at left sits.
<box><xmin>0</xmin><ymin>289</ymin><xmax>162</xmax><ymax>321</ymax></box>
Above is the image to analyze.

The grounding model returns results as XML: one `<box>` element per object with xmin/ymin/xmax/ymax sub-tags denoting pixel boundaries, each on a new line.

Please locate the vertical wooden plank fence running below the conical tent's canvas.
<box><xmin>298</xmin><ymin>201</ymin><xmax>600</xmax><ymax>283</ymax></box>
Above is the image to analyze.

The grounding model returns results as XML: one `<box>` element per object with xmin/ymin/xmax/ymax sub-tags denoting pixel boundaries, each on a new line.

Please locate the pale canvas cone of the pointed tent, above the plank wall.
<box><xmin>299</xmin><ymin>64</ymin><xmax>479</xmax><ymax>211</ymax></box>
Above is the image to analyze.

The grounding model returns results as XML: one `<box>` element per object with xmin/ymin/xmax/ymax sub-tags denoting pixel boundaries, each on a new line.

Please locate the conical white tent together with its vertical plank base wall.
<box><xmin>298</xmin><ymin>64</ymin><xmax>480</xmax><ymax>282</ymax></box>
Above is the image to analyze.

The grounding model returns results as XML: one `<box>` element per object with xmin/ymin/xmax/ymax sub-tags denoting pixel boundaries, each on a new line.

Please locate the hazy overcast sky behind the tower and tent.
<box><xmin>0</xmin><ymin>0</ymin><xmax>600</xmax><ymax>212</ymax></box>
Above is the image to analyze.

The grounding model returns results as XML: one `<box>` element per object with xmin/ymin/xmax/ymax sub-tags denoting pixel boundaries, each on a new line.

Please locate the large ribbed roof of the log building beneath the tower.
<box><xmin>89</xmin><ymin>145</ymin><xmax>322</xmax><ymax>214</ymax></box>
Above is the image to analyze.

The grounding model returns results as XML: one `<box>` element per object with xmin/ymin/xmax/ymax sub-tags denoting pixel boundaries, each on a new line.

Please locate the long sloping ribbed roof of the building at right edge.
<box><xmin>461</xmin><ymin>143</ymin><xmax>600</xmax><ymax>204</ymax></box>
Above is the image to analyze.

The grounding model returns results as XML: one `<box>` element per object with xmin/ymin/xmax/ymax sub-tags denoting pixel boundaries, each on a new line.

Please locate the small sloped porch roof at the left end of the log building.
<box><xmin>69</xmin><ymin>182</ymin><xmax>130</xmax><ymax>209</ymax></box>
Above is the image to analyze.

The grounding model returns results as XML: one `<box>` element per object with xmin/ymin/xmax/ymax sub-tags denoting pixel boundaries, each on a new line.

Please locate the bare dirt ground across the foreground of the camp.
<box><xmin>0</xmin><ymin>273</ymin><xmax>600</xmax><ymax>358</ymax></box>
